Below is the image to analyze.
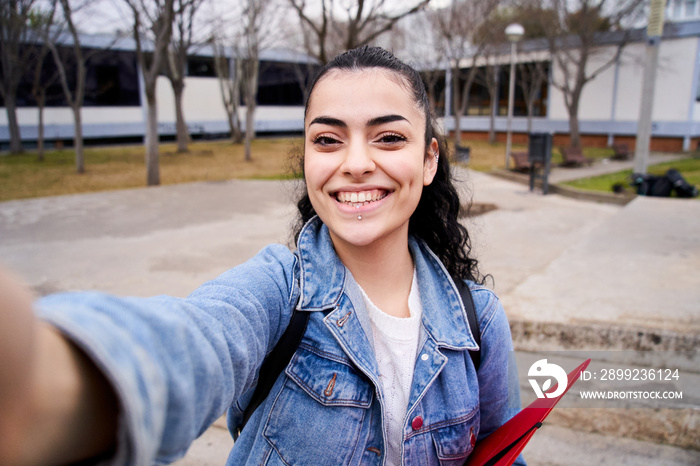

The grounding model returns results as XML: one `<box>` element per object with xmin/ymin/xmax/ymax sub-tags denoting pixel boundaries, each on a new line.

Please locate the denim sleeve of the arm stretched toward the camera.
<box><xmin>35</xmin><ymin>245</ymin><xmax>298</xmax><ymax>464</ymax></box>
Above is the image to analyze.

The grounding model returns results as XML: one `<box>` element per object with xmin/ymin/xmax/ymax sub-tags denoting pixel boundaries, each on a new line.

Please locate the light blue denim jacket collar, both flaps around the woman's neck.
<box><xmin>296</xmin><ymin>217</ymin><xmax>478</xmax><ymax>349</ymax></box>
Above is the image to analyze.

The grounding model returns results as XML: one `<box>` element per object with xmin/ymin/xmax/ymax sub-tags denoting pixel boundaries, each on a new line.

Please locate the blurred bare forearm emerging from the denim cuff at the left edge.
<box><xmin>0</xmin><ymin>271</ymin><xmax>118</xmax><ymax>464</ymax></box>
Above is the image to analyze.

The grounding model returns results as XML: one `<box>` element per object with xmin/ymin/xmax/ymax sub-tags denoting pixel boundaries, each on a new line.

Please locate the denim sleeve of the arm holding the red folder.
<box><xmin>472</xmin><ymin>287</ymin><xmax>525</xmax><ymax>466</ymax></box>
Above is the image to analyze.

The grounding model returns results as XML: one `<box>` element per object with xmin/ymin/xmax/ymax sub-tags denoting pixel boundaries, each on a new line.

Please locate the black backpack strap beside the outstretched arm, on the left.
<box><xmin>238</xmin><ymin>309</ymin><xmax>309</xmax><ymax>432</ymax></box>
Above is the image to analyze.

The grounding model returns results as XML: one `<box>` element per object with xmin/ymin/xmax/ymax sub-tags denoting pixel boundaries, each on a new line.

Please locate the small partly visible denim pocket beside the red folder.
<box><xmin>432</xmin><ymin>412</ymin><xmax>479</xmax><ymax>465</ymax></box>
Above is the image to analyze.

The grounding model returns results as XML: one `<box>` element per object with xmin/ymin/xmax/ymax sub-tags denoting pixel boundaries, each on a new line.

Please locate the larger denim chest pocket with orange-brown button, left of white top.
<box><xmin>263</xmin><ymin>346</ymin><xmax>373</xmax><ymax>465</ymax></box>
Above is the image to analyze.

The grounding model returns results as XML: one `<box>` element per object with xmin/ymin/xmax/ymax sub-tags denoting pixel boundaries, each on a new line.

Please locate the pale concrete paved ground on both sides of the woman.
<box><xmin>0</xmin><ymin>162</ymin><xmax>700</xmax><ymax>465</ymax></box>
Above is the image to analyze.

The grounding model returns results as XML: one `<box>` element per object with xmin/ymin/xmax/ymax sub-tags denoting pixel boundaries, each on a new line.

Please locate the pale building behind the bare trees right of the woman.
<box><xmin>437</xmin><ymin>20</ymin><xmax>700</xmax><ymax>151</ymax></box>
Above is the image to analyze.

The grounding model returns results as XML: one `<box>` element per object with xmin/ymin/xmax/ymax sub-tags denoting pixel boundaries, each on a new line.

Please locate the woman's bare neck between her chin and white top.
<box><xmin>331</xmin><ymin>231</ymin><xmax>413</xmax><ymax>317</ymax></box>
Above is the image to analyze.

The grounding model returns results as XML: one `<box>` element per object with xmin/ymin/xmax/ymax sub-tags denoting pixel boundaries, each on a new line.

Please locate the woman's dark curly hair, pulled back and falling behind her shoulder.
<box><xmin>294</xmin><ymin>46</ymin><xmax>484</xmax><ymax>283</ymax></box>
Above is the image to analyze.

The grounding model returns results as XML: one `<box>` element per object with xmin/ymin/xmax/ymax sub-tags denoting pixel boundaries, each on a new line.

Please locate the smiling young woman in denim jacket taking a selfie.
<box><xmin>0</xmin><ymin>47</ymin><xmax>520</xmax><ymax>465</ymax></box>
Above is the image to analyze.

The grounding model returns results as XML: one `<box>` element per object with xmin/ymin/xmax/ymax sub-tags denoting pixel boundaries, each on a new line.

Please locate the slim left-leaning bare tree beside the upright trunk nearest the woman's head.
<box><xmin>211</xmin><ymin>37</ymin><xmax>243</xmax><ymax>144</ymax></box>
